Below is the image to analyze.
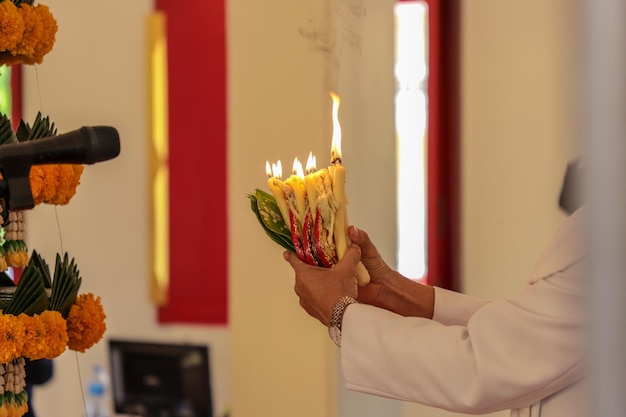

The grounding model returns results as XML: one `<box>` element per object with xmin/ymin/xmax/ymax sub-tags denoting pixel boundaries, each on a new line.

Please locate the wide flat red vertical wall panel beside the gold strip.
<box><xmin>156</xmin><ymin>0</ymin><xmax>228</xmax><ymax>324</ymax></box>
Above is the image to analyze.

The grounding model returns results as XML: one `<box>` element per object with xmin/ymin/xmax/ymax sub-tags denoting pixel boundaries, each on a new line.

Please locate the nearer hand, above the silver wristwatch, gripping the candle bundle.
<box><xmin>283</xmin><ymin>245</ymin><xmax>361</xmax><ymax>326</ymax></box>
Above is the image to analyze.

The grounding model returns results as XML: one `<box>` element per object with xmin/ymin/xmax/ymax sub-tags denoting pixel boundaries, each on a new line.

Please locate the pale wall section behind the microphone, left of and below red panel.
<box><xmin>24</xmin><ymin>0</ymin><xmax>230</xmax><ymax>417</ymax></box>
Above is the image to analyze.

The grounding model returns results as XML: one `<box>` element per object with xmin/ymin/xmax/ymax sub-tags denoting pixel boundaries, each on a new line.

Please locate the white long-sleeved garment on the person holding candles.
<box><xmin>341</xmin><ymin>209</ymin><xmax>588</xmax><ymax>417</ymax></box>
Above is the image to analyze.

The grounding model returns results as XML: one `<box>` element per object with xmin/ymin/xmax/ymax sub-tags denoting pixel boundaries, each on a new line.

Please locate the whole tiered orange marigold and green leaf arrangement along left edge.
<box><xmin>0</xmin><ymin>4</ymin><xmax>106</xmax><ymax>417</ymax></box>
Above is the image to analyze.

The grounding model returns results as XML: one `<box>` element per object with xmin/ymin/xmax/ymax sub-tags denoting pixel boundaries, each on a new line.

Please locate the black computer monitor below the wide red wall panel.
<box><xmin>109</xmin><ymin>340</ymin><xmax>213</xmax><ymax>417</ymax></box>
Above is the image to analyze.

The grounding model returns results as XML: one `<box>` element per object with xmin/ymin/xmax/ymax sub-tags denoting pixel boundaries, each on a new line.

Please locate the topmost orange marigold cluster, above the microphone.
<box><xmin>0</xmin><ymin>0</ymin><xmax>58</xmax><ymax>65</ymax></box>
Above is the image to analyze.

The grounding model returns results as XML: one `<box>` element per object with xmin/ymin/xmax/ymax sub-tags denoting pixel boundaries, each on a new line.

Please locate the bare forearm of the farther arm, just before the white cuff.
<box><xmin>376</xmin><ymin>273</ymin><xmax>435</xmax><ymax>319</ymax></box>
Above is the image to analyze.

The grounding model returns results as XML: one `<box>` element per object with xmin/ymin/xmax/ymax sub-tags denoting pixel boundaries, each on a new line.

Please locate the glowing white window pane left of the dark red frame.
<box><xmin>394</xmin><ymin>1</ymin><xmax>428</xmax><ymax>279</ymax></box>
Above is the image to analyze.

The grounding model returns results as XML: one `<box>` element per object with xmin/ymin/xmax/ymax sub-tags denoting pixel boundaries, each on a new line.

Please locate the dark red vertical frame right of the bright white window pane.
<box><xmin>399</xmin><ymin>0</ymin><xmax>460</xmax><ymax>290</ymax></box>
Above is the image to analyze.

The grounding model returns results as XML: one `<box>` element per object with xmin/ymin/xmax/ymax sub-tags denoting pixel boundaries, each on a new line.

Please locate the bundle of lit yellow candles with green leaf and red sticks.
<box><xmin>249</xmin><ymin>91</ymin><xmax>369</xmax><ymax>285</ymax></box>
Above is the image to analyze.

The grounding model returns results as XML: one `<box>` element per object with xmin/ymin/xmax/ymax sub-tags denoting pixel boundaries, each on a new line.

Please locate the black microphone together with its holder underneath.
<box><xmin>0</xmin><ymin>126</ymin><xmax>120</xmax><ymax>210</ymax></box>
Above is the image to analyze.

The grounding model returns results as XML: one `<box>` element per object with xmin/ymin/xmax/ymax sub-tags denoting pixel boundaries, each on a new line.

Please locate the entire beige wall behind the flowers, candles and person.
<box><xmin>19</xmin><ymin>0</ymin><xmax>577</xmax><ymax>417</ymax></box>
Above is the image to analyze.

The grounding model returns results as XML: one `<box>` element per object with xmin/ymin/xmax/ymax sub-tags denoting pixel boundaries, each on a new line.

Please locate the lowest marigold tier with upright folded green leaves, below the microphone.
<box><xmin>0</xmin><ymin>251</ymin><xmax>106</xmax><ymax>417</ymax></box>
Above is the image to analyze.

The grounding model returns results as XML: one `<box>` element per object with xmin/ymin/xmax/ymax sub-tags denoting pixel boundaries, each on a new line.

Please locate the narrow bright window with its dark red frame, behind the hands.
<box><xmin>394</xmin><ymin>0</ymin><xmax>460</xmax><ymax>290</ymax></box>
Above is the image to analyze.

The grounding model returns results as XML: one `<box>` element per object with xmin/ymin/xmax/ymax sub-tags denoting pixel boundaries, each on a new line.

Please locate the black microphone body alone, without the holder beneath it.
<box><xmin>0</xmin><ymin>126</ymin><xmax>120</xmax><ymax>170</ymax></box>
